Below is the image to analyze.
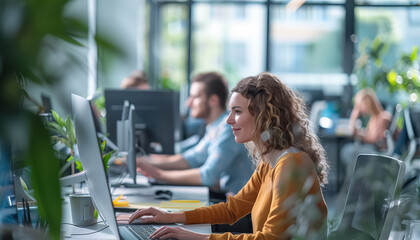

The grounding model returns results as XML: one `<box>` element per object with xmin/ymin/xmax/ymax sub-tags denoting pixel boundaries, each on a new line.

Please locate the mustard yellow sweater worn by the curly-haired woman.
<box><xmin>185</xmin><ymin>152</ymin><xmax>327</xmax><ymax>240</ymax></box>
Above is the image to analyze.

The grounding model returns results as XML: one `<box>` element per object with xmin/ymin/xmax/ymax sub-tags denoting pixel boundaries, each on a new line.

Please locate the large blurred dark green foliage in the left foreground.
<box><xmin>0</xmin><ymin>0</ymin><xmax>118</xmax><ymax>239</ymax></box>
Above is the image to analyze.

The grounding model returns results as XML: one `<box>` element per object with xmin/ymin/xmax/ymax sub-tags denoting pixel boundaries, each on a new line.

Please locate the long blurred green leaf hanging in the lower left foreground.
<box><xmin>25</xmin><ymin>115</ymin><xmax>61</xmax><ymax>239</ymax></box>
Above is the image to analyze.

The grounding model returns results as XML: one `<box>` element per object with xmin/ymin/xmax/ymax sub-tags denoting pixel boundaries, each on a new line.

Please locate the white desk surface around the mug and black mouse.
<box><xmin>62</xmin><ymin>181</ymin><xmax>211</xmax><ymax>239</ymax></box>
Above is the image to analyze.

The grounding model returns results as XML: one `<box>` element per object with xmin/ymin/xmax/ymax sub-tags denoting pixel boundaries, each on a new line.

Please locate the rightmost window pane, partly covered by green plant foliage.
<box><xmin>355</xmin><ymin>7</ymin><xmax>420</xmax><ymax>90</ymax></box>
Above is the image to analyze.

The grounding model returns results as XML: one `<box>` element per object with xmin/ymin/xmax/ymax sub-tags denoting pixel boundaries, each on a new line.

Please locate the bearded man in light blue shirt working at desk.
<box><xmin>137</xmin><ymin>72</ymin><xmax>254</xmax><ymax>194</ymax></box>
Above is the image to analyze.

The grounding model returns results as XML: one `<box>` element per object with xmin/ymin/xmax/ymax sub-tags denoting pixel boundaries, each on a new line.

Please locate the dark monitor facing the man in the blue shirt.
<box><xmin>105</xmin><ymin>89</ymin><xmax>180</xmax><ymax>154</ymax></box>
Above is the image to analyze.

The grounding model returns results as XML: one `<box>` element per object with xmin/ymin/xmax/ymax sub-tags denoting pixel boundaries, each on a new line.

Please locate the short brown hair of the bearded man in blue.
<box><xmin>191</xmin><ymin>72</ymin><xmax>228</xmax><ymax>109</ymax></box>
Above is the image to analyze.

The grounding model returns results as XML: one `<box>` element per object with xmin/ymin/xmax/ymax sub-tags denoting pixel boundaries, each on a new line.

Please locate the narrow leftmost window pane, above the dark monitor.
<box><xmin>157</xmin><ymin>4</ymin><xmax>188</xmax><ymax>90</ymax></box>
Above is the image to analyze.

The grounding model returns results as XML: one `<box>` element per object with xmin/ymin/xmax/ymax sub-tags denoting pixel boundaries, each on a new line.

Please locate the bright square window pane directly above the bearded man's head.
<box><xmin>192</xmin><ymin>4</ymin><xmax>266</xmax><ymax>87</ymax></box>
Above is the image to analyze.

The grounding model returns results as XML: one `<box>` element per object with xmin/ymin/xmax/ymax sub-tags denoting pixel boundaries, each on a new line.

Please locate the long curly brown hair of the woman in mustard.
<box><xmin>231</xmin><ymin>73</ymin><xmax>329</xmax><ymax>185</ymax></box>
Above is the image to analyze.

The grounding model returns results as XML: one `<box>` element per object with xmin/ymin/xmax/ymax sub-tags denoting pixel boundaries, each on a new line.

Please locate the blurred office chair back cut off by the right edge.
<box><xmin>404</xmin><ymin>105</ymin><xmax>420</xmax><ymax>169</ymax></box>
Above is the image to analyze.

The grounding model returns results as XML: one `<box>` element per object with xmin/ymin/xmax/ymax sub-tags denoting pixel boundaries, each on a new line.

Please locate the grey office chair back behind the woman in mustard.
<box><xmin>328</xmin><ymin>154</ymin><xmax>405</xmax><ymax>240</ymax></box>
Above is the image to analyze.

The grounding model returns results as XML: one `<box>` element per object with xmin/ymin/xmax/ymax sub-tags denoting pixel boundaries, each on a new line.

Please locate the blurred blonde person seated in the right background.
<box><xmin>340</xmin><ymin>88</ymin><xmax>392</xmax><ymax>164</ymax></box>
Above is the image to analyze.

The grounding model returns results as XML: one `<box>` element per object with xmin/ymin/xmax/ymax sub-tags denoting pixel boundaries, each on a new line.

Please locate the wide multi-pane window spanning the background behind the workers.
<box><xmin>150</xmin><ymin>0</ymin><xmax>420</xmax><ymax>92</ymax></box>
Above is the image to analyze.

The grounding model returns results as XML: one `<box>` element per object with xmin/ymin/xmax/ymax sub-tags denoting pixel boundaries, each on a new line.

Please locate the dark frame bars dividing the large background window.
<box><xmin>148</xmin><ymin>0</ymin><xmax>420</xmax><ymax>86</ymax></box>
